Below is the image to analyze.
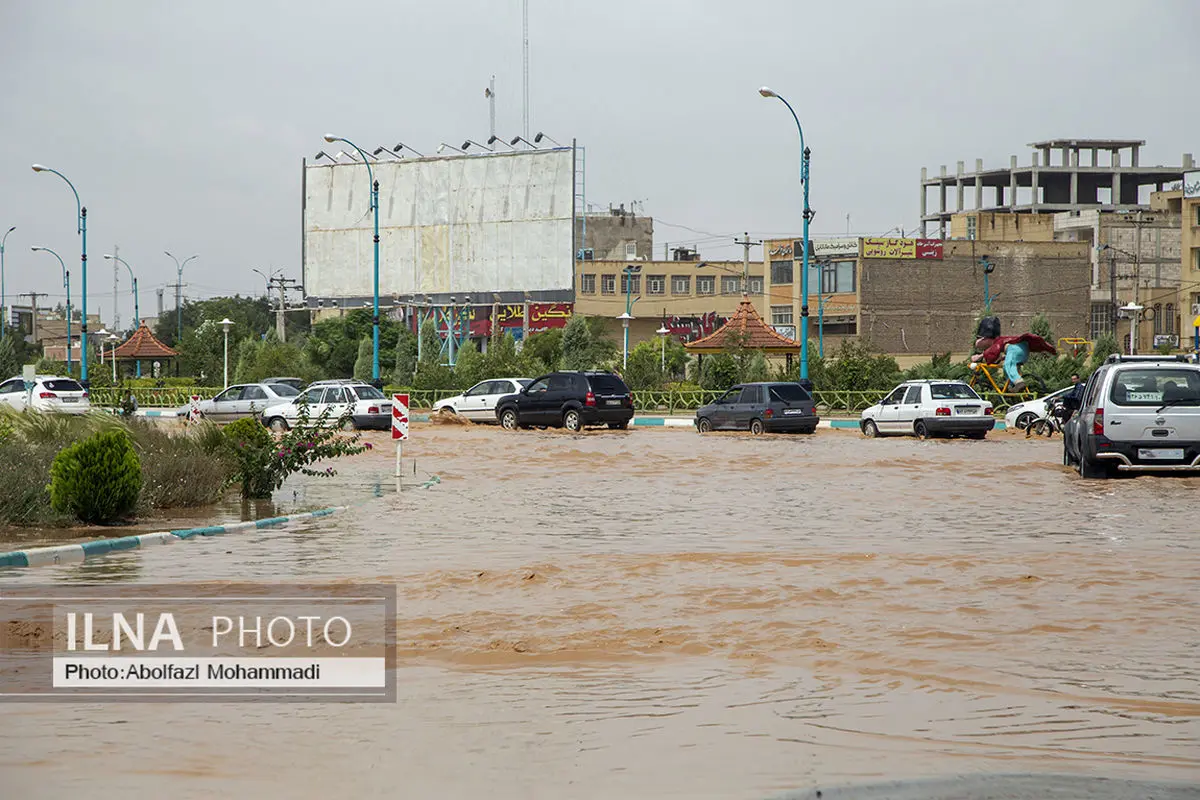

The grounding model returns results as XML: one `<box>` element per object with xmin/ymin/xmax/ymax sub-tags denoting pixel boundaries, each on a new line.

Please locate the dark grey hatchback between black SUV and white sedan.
<box><xmin>692</xmin><ymin>383</ymin><xmax>820</xmax><ymax>434</ymax></box>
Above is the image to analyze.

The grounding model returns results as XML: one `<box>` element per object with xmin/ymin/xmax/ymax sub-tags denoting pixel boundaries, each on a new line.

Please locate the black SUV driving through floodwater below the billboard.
<box><xmin>496</xmin><ymin>372</ymin><xmax>634</xmax><ymax>431</ymax></box>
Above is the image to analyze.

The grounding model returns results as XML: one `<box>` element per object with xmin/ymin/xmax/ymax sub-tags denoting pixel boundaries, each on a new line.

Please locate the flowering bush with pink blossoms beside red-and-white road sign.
<box><xmin>224</xmin><ymin>407</ymin><xmax>371</xmax><ymax>498</ymax></box>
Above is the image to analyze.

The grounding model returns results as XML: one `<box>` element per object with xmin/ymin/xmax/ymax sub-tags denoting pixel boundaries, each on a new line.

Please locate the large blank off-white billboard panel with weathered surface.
<box><xmin>304</xmin><ymin>148</ymin><xmax>575</xmax><ymax>297</ymax></box>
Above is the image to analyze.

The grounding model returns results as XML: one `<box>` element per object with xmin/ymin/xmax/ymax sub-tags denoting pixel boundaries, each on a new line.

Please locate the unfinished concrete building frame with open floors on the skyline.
<box><xmin>920</xmin><ymin>139</ymin><xmax>1194</xmax><ymax>240</ymax></box>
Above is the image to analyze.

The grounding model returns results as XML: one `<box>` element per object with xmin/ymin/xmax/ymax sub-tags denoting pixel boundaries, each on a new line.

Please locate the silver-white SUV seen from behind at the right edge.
<box><xmin>1062</xmin><ymin>355</ymin><xmax>1200</xmax><ymax>477</ymax></box>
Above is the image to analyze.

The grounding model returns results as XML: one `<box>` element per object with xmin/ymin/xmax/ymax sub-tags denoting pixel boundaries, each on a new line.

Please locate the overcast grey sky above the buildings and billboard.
<box><xmin>0</xmin><ymin>0</ymin><xmax>1200</xmax><ymax>323</ymax></box>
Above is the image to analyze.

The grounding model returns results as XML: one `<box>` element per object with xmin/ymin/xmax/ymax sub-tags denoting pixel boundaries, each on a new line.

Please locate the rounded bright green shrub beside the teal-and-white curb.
<box><xmin>50</xmin><ymin>429</ymin><xmax>142</xmax><ymax>524</ymax></box>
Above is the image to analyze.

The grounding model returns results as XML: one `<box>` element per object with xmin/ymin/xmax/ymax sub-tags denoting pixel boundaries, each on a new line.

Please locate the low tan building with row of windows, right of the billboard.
<box><xmin>575</xmin><ymin>260</ymin><xmax>764</xmax><ymax>345</ymax></box>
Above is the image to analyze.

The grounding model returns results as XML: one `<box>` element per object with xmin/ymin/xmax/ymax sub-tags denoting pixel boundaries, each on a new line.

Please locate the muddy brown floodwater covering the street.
<box><xmin>0</xmin><ymin>425</ymin><xmax>1200</xmax><ymax>800</ymax></box>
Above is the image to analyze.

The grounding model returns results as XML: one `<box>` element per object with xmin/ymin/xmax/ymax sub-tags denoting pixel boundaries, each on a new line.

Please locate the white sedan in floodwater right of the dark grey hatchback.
<box><xmin>859</xmin><ymin>380</ymin><xmax>996</xmax><ymax>439</ymax></box>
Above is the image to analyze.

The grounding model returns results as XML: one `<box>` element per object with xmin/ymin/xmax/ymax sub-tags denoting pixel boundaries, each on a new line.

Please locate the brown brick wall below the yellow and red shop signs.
<box><xmin>859</xmin><ymin>241</ymin><xmax>1091</xmax><ymax>355</ymax></box>
